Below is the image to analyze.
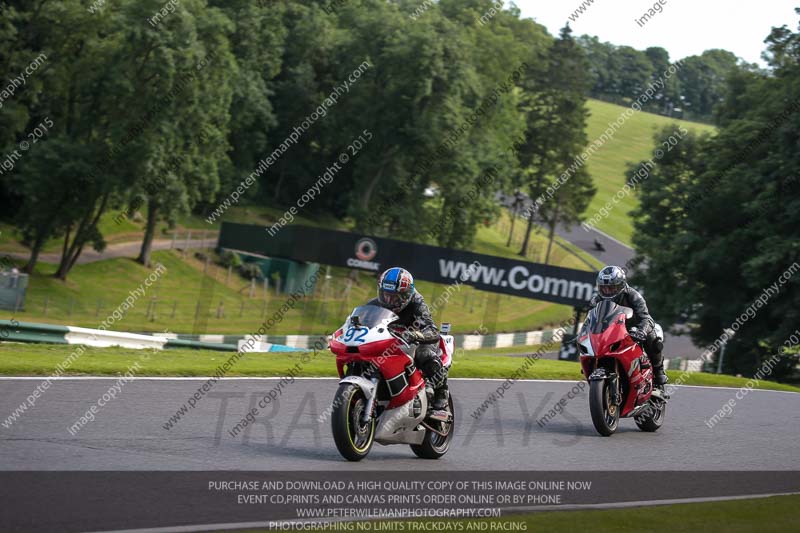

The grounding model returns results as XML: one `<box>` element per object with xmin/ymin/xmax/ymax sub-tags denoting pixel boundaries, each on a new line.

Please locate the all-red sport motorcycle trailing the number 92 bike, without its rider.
<box><xmin>577</xmin><ymin>300</ymin><xmax>669</xmax><ymax>437</ymax></box>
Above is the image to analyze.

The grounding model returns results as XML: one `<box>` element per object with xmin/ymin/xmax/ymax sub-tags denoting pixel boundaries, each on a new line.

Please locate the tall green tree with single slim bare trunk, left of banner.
<box><xmin>117</xmin><ymin>0</ymin><xmax>238</xmax><ymax>265</ymax></box>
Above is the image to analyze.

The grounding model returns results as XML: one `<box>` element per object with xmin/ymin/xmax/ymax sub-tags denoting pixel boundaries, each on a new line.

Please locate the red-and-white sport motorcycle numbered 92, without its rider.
<box><xmin>330</xmin><ymin>305</ymin><xmax>455</xmax><ymax>461</ymax></box>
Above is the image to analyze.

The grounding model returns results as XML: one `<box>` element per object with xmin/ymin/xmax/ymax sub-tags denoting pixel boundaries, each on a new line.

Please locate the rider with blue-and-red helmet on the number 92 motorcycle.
<box><xmin>368</xmin><ymin>267</ymin><xmax>449</xmax><ymax>411</ymax></box>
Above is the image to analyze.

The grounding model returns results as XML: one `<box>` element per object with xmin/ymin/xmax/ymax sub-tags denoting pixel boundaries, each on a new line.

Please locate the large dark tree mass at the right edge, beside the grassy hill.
<box><xmin>634</xmin><ymin>10</ymin><xmax>800</xmax><ymax>377</ymax></box>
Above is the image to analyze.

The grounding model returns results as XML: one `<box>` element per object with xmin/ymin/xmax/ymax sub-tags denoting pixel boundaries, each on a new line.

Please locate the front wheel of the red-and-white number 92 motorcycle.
<box><xmin>331</xmin><ymin>383</ymin><xmax>375</xmax><ymax>461</ymax></box>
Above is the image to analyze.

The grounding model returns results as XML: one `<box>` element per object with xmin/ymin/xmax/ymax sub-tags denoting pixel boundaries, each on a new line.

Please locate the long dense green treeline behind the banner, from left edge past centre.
<box><xmin>0</xmin><ymin>0</ymin><xmax>748</xmax><ymax>278</ymax></box>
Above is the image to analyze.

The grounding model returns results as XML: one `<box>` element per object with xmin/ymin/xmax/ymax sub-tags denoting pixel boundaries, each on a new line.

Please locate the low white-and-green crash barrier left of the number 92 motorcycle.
<box><xmin>0</xmin><ymin>320</ymin><xmax>298</xmax><ymax>352</ymax></box>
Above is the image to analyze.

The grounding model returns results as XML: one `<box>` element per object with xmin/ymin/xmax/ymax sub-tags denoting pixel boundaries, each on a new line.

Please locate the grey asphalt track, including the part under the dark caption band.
<box><xmin>0</xmin><ymin>378</ymin><xmax>800</xmax><ymax>533</ymax></box>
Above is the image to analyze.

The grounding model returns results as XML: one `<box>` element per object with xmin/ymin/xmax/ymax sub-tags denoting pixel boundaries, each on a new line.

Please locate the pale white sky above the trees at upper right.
<box><xmin>514</xmin><ymin>0</ymin><xmax>800</xmax><ymax>66</ymax></box>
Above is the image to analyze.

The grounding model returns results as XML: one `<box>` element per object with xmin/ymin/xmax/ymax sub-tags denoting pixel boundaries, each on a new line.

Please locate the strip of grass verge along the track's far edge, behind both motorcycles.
<box><xmin>0</xmin><ymin>343</ymin><xmax>800</xmax><ymax>392</ymax></box>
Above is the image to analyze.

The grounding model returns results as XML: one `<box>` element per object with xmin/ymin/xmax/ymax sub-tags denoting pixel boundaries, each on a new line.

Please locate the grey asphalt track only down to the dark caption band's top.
<box><xmin>0</xmin><ymin>378</ymin><xmax>800</xmax><ymax>471</ymax></box>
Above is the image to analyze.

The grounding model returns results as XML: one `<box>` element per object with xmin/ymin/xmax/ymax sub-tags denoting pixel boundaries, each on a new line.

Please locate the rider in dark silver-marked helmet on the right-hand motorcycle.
<box><xmin>590</xmin><ymin>266</ymin><xmax>669</xmax><ymax>385</ymax></box>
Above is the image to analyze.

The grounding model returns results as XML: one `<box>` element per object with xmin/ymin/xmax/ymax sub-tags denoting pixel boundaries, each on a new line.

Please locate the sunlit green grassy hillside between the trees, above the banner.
<box><xmin>586</xmin><ymin>100</ymin><xmax>714</xmax><ymax>244</ymax></box>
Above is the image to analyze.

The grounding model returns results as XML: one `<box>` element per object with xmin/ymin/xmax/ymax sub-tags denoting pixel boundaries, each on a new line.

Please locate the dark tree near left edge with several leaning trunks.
<box><xmin>3</xmin><ymin>1</ymin><xmax>129</xmax><ymax>278</ymax></box>
